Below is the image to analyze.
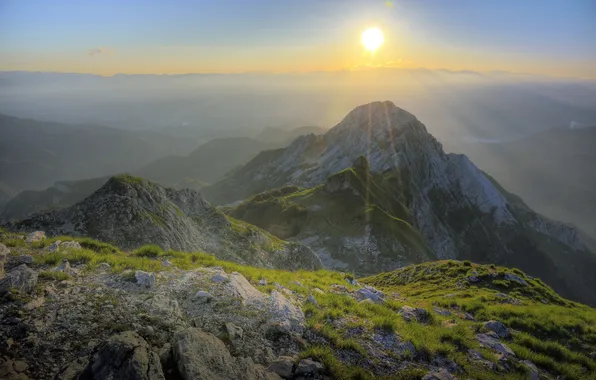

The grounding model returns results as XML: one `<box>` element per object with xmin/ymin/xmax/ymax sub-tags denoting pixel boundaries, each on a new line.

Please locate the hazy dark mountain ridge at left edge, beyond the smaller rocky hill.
<box><xmin>0</xmin><ymin>115</ymin><xmax>193</xmax><ymax>192</ymax></box>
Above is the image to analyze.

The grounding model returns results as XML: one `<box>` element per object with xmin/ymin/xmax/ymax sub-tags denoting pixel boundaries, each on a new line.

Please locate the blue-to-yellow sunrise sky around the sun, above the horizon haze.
<box><xmin>0</xmin><ymin>0</ymin><xmax>596</xmax><ymax>78</ymax></box>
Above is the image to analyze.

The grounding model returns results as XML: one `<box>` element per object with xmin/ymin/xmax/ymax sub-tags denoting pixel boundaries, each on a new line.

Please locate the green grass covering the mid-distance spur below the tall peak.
<box><xmin>226</xmin><ymin>162</ymin><xmax>433</xmax><ymax>273</ymax></box>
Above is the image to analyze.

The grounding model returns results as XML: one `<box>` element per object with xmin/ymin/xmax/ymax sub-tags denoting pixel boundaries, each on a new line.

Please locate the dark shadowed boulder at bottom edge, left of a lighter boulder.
<box><xmin>80</xmin><ymin>331</ymin><xmax>165</xmax><ymax>380</ymax></box>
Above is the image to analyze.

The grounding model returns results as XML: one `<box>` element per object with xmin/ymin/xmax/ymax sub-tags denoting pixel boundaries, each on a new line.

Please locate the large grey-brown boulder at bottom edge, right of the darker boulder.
<box><xmin>172</xmin><ymin>328</ymin><xmax>262</xmax><ymax>380</ymax></box>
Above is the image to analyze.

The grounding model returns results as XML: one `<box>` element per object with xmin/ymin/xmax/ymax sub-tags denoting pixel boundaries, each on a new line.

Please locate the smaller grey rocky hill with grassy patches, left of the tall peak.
<box><xmin>10</xmin><ymin>175</ymin><xmax>321</xmax><ymax>269</ymax></box>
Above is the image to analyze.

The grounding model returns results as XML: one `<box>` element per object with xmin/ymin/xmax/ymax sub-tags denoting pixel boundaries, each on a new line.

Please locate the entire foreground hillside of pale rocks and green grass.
<box><xmin>0</xmin><ymin>231</ymin><xmax>596</xmax><ymax>380</ymax></box>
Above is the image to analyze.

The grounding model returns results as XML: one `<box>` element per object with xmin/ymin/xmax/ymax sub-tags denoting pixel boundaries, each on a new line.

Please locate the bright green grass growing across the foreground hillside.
<box><xmin>0</xmin><ymin>229</ymin><xmax>596</xmax><ymax>379</ymax></box>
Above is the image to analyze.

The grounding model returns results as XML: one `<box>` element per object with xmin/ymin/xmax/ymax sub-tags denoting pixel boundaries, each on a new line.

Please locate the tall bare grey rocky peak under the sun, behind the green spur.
<box><xmin>203</xmin><ymin>102</ymin><xmax>596</xmax><ymax>303</ymax></box>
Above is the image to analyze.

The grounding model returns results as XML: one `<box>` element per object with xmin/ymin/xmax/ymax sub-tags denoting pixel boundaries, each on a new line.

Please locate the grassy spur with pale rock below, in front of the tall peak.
<box><xmin>224</xmin><ymin>156</ymin><xmax>435</xmax><ymax>275</ymax></box>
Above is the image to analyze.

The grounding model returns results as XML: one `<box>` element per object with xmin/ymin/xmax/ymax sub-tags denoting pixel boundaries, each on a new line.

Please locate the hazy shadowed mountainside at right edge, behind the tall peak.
<box><xmin>460</xmin><ymin>127</ymin><xmax>596</xmax><ymax>237</ymax></box>
